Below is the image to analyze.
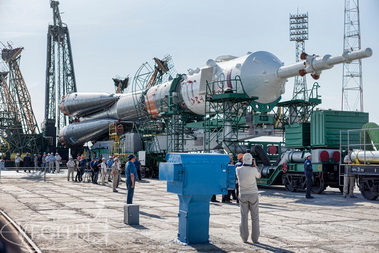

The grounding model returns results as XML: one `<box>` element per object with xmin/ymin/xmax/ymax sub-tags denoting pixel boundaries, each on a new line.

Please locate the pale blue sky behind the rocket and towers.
<box><xmin>0</xmin><ymin>0</ymin><xmax>379</xmax><ymax>125</ymax></box>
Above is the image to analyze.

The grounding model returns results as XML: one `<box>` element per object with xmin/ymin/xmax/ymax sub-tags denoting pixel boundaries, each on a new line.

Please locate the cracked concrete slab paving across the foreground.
<box><xmin>0</xmin><ymin>168</ymin><xmax>379</xmax><ymax>253</ymax></box>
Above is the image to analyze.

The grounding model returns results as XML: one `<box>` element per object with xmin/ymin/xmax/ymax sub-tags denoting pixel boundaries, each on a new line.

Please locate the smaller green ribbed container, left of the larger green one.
<box><xmin>285</xmin><ymin>123</ymin><xmax>311</xmax><ymax>148</ymax></box>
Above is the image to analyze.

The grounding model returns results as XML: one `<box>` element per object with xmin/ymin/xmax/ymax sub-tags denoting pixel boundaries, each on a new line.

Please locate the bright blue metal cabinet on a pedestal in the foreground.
<box><xmin>159</xmin><ymin>153</ymin><xmax>236</xmax><ymax>244</ymax></box>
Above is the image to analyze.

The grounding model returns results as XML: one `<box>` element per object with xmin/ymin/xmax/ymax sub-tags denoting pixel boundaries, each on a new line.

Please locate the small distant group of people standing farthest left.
<box><xmin>14</xmin><ymin>153</ymin><xmax>62</xmax><ymax>173</ymax></box>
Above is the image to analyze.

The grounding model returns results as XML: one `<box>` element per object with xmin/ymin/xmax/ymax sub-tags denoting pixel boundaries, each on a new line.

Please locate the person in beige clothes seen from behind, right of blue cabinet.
<box><xmin>236</xmin><ymin>153</ymin><xmax>261</xmax><ymax>243</ymax></box>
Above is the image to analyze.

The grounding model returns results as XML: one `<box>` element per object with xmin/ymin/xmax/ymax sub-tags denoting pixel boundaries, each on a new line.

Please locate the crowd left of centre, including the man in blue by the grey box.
<box><xmin>66</xmin><ymin>154</ymin><xmax>142</xmax><ymax>204</ymax></box>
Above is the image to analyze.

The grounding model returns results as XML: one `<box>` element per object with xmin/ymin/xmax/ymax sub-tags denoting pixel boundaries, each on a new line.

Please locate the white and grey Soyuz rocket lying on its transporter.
<box><xmin>59</xmin><ymin>48</ymin><xmax>373</xmax><ymax>146</ymax></box>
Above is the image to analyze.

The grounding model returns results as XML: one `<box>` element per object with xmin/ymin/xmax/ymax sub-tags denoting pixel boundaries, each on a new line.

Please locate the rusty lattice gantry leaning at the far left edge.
<box><xmin>0</xmin><ymin>44</ymin><xmax>40</xmax><ymax>153</ymax></box>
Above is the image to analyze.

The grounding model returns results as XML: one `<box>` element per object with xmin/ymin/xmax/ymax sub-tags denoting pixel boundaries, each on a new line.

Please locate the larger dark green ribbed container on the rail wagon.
<box><xmin>311</xmin><ymin>110</ymin><xmax>368</xmax><ymax>148</ymax></box>
